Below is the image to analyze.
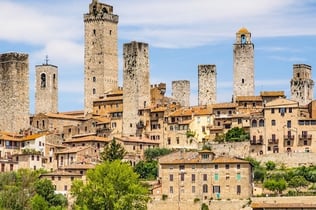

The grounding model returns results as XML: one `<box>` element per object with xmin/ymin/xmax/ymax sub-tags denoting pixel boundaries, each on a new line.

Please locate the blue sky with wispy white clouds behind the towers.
<box><xmin>0</xmin><ymin>0</ymin><xmax>316</xmax><ymax>113</ymax></box>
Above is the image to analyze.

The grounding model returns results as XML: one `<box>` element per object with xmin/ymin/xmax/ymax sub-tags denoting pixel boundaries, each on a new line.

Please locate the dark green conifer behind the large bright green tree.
<box><xmin>100</xmin><ymin>138</ymin><xmax>126</xmax><ymax>161</ymax></box>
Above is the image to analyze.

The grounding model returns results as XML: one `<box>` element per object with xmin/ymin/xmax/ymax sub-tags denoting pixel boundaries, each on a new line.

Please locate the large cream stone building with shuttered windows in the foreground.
<box><xmin>156</xmin><ymin>150</ymin><xmax>252</xmax><ymax>202</ymax></box>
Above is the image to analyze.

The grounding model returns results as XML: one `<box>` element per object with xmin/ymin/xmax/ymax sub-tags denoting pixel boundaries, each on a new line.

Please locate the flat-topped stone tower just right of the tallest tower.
<box><xmin>123</xmin><ymin>41</ymin><xmax>151</xmax><ymax>136</ymax></box>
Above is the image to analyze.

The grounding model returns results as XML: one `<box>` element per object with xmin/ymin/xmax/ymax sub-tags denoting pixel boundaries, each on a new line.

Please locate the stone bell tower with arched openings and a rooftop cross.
<box><xmin>35</xmin><ymin>59</ymin><xmax>58</xmax><ymax>114</ymax></box>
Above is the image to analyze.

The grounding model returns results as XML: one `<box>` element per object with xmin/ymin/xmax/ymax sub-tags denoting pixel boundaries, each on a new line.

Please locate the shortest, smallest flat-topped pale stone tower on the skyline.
<box><xmin>172</xmin><ymin>80</ymin><xmax>190</xmax><ymax>106</ymax></box>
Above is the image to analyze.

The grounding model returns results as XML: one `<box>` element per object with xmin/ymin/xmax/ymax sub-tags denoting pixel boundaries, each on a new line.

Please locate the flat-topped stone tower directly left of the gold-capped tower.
<box><xmin>198</xmin><ymin>65</ymin><xmax>216</xmax><ymax>105</ymax></box>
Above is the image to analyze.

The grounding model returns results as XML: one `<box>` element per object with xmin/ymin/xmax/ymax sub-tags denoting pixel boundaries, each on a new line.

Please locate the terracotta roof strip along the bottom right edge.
<box><xmin>251</xmin><ymin>202</ymin><xmax>316</xmax><ymax>209</ymax></box>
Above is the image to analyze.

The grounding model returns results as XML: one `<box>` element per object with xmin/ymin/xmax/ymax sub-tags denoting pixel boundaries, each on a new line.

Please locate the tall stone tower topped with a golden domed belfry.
<box><xmin>233</xmin><ymin>28</ymin><xmax>255</xmax><ymax>101</ymax></box>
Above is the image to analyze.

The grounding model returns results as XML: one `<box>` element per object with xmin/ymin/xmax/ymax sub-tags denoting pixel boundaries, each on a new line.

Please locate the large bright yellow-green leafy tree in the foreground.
<box><xmin>71</xmin><ymin>160</ymin><xmax>149</xmax><ymax>210</ymax></box>
